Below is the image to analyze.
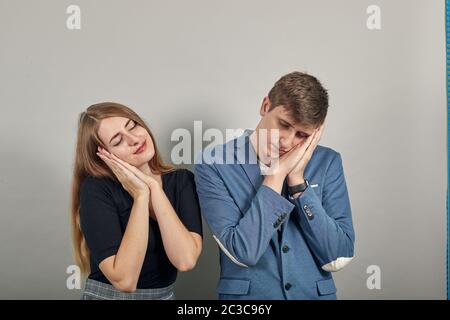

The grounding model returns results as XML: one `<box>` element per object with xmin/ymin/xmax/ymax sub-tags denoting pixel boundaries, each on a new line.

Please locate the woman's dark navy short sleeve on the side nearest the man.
<box><xmin>177</xmin><ymin>170</ymin><xmax>203</xmax><ymax>236</ymax></box>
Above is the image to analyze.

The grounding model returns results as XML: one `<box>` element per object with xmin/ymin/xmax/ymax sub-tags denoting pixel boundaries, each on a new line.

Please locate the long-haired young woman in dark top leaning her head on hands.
<box><xmin>71</xmin><ymin>102</ymin><xmax>202</xmax><ymax>299</ymax></box>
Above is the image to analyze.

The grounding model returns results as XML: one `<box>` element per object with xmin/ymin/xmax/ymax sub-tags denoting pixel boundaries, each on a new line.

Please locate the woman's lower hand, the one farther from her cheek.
<box><xmin>97</xmin><ymin>147</ymin><xmax>150</xmax><ymax>200</ymax></box>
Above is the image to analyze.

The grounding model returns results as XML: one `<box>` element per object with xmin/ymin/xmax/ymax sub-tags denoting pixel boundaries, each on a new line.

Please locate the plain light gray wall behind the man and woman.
<box><xmin>0</xmin><ymin>0</ymin><xmax>447</xmax><ymax>299</ymax></box>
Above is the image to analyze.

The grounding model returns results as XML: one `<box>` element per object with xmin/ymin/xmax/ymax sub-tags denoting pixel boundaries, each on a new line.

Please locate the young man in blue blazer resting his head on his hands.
<box><xmin>195</xmin><ymin>72</ymin><xmax>354</xmax><ymax>299</ymax></box>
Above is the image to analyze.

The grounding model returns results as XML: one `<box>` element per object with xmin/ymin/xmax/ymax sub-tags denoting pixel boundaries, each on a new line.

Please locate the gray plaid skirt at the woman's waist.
<box><xmin>81</xmin><ymin>279</ymin><xmax>175</xmax><ymax>300</ymax></box>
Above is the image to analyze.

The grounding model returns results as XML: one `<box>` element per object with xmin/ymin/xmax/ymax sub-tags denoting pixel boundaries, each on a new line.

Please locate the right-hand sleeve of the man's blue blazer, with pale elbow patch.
<box><xmin>291</xmin><ymin>152</ymin><xmax>355</xmax><ymax>272</ymax></box>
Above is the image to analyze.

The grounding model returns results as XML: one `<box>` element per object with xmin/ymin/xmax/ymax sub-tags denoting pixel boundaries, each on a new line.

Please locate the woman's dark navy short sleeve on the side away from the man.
<box><xmin>80</xmin><ymin>177</ymin><xmax>122</xmax><ymax>265</ymax></box>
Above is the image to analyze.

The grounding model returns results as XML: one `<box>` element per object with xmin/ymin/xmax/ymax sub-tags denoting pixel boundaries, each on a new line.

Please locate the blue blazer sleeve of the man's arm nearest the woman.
<box><xmin>195</xmin><ymin>163</ymin><xmax>295</xmax><ymax>267</ymax></box>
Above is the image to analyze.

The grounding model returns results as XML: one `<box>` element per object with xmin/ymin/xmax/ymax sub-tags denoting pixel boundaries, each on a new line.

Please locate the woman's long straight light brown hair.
<box><xmin>70</xmin><ymin>102</ymin><xmax>174</xmax><ymax>274</ymax></box>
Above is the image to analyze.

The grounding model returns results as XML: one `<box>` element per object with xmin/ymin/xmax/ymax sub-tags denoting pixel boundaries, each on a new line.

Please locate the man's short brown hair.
<box><xmin>269</xmin><ymin>71</ymin><xmax>328</xmax><ymax>127</ymax></box>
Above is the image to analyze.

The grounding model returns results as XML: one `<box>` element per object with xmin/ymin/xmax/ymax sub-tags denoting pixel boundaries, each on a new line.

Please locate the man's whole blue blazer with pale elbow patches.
<box><xmin>195</xmin><ymin>130</ymin><xmax>355</xmax><ymax>299</ymax></box>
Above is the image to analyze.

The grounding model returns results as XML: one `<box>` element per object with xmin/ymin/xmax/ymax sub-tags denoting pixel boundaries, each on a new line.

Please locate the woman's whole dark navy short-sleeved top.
<box><xmin>80</xmin><ymin>169</ymin><xmax>203</xmax><ymax>289</ymax></box>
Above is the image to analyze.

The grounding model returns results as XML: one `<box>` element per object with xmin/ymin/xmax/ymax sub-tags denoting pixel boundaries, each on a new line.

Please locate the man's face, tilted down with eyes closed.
<box><xmin>258</xmin><ymin>97</ymin><xmax>315</xmax><ymax>158</ymax></box>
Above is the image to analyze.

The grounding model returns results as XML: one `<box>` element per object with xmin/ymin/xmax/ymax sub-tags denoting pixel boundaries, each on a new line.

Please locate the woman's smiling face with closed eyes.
<box><xmin>98</xmin><ymin>117</ymin><xmax>155</xmax><ymax>168</ymax></box>
